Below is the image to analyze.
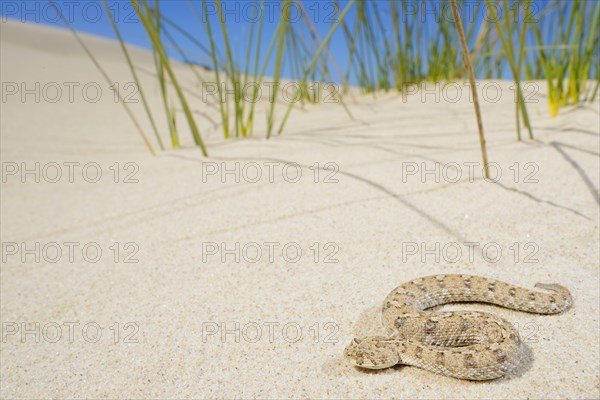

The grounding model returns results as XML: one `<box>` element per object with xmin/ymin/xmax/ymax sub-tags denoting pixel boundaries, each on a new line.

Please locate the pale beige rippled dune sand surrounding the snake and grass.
<box><xmin>0</xmin><ymin>21</ymin><xmax>600</xmax><ymax>398</ymax></box>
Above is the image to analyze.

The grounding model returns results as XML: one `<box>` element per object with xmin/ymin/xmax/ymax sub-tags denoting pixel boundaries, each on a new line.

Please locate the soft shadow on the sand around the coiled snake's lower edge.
<box><xmin>321</xmin><ymin>303</ymin><xmax>534</xmax><ymax>385</ymax></box>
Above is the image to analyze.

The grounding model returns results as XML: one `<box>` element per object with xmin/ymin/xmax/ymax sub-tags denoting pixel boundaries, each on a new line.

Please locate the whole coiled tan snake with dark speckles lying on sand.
<box><xmin>344</xmin><ymin>275</ymin><xmax>572</xmax><ymax>380</ymax></box>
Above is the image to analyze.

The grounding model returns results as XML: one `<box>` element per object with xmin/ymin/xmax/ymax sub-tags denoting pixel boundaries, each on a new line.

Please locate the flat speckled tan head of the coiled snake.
<box><xmin>344</xmin><ymin>336</ymin><xmax>400</xmax><ymax>369</ymax></box>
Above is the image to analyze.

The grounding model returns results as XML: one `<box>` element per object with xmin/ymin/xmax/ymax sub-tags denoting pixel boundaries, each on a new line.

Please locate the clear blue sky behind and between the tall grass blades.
<box><xmin>0</xmin><ymin>0</ymin><xmax>580</xmax><ymax>83</ymax></box>
